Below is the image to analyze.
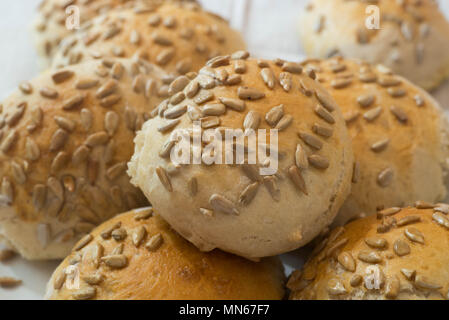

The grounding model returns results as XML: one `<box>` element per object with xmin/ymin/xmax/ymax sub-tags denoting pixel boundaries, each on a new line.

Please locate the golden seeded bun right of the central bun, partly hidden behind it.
<box><xmin>304</xmin><ymin>58</ymin><xmax>449</xmax><ymax>224</ymax></box>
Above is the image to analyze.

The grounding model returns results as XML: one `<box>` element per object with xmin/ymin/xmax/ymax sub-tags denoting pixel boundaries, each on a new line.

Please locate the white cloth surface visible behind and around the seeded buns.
<box><xmin>0</xmin><ymin>0</ymin><xmax>449</xmax><ymax>299</ymax></box>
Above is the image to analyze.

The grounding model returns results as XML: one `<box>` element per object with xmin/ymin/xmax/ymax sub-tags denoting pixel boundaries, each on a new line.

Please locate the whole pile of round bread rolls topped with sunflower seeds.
<box><xmin>0</xmin><ymin>0</ymin><xmax>449</xmax><ymax>300</ymax></box>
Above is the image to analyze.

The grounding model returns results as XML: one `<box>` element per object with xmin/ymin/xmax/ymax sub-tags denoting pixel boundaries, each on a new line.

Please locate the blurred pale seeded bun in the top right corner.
<box><xmin>300</xmin><ymin>0</ymin><xmax>449</xmax><ymax>89</ymax></box>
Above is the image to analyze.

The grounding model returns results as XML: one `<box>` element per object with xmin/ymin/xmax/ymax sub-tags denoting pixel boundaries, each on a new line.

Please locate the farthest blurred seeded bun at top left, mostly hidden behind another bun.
<box><xmin>33</xmin><ymin>0</ymin><xmax>199</xmax><ymax>67</ymax></box>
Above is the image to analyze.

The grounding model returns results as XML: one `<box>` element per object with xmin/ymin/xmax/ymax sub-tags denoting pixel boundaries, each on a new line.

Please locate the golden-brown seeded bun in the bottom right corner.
<box><xmin>287</xmin><ymin>205</ymin><xmax>449</xmax><ymax>300</ymax></box>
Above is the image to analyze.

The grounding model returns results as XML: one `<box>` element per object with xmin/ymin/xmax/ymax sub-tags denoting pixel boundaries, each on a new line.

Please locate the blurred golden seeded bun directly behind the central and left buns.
<box><xmin>53</xmin><ymin>2</ymin><xmax>245</xmax><ymax>74</ymax></box>
